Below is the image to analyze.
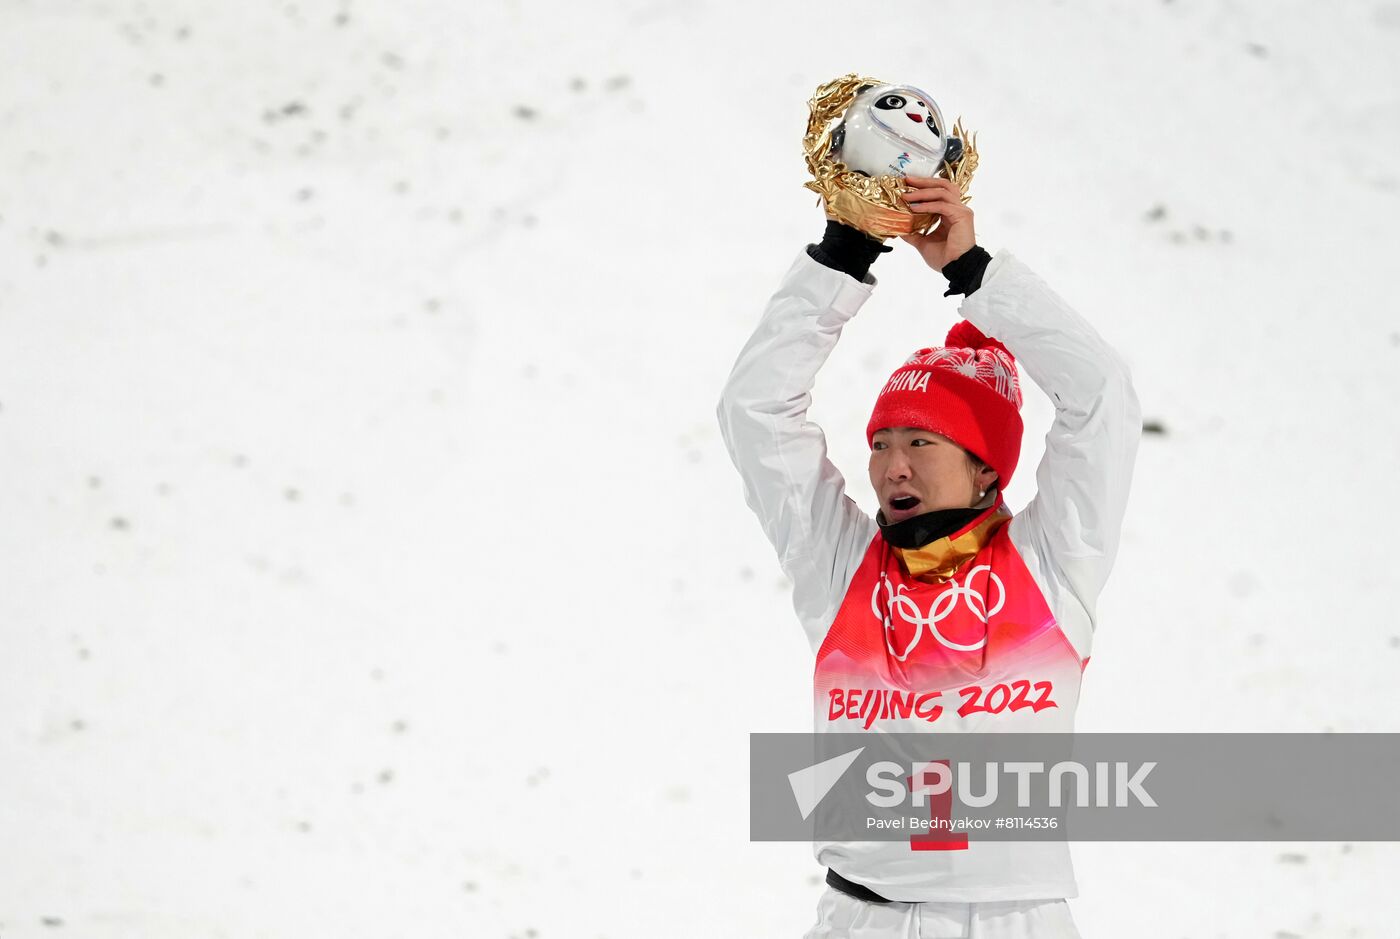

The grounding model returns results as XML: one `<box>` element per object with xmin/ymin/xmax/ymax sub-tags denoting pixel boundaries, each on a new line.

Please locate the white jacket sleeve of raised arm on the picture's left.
<box><xmin>718</xmin><ymin>250</ymin><xmax>876</xmax><ymax>649</ymax></box>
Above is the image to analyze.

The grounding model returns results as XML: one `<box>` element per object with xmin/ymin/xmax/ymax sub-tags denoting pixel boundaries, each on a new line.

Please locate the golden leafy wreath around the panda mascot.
<box><xmin>802</xmin><ymin>73</ymin><xmax>977</xmax><ymax>239</ymax></box>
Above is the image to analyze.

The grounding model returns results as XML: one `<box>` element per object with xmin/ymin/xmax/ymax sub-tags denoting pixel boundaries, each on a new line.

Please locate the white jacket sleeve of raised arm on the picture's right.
<box><xmin>959</xmin><ymin>250</ymin><xmax>1142</xmax><ymax>658</ymax></box>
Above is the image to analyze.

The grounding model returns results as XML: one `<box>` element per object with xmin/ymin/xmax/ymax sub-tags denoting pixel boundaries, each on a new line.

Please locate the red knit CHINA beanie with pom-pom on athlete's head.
<box><xmin>865</xmin><ymin>319</ymin><xmax>1022</xmax><ymax>491</ymax></box>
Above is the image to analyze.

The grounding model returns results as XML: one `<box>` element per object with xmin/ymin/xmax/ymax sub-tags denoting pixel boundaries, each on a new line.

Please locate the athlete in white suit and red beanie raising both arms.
<box><xmin>718</xmin><ymin>176</ymin><xmax>1142</xmax><ymax>939</ymax></box>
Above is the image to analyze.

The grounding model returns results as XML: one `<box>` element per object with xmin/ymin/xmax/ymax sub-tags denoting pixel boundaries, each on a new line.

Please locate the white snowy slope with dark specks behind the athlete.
<box><xmin>0</xmin><ymin>0</ymin><xmax>1400</xmax><ymax>939</ymax></box>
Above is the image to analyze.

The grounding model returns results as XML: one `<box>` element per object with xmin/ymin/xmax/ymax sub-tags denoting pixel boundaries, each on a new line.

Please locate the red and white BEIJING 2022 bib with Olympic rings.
<box><xmin>813</xmin><ymin>505</ymin><xmax>1082</xmax><ymax>901</ymax></box>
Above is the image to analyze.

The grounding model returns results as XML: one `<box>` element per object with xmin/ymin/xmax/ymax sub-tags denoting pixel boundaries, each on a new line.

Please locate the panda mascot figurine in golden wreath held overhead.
<box><xmin>802</xmin><ymin>73</ymin><xmax>977</xmax><ymax>241</ymax></box>
